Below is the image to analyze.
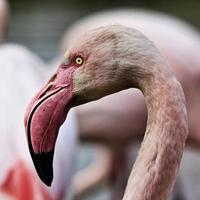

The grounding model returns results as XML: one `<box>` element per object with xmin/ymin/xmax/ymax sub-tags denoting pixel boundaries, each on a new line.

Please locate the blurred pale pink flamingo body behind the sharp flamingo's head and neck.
<box><xmin>58</xmin><ymin>9</ymin><xmax>200</xmax><ymax>196</ymax></box>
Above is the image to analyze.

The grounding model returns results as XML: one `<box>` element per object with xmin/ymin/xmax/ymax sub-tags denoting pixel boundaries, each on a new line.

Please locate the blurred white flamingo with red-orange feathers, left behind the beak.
<box><xmin>0</xmin><ymin>44</ymin><xmax>77</xmax><ymax>200</ymax></box>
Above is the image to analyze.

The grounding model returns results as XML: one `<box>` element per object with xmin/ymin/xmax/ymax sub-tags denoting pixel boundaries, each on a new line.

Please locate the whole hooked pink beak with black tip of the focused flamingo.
<box><xmin>25</xmin><ymin>67</ymin><xmax>74</xmax><ymax>186</ymax></box>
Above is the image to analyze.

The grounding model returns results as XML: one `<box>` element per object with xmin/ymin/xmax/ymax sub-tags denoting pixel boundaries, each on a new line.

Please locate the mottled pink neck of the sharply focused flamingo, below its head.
<box><xmin>123</xmin><ymin>64</ymin><xmax>188</xmax><ymax>200</ymax></box>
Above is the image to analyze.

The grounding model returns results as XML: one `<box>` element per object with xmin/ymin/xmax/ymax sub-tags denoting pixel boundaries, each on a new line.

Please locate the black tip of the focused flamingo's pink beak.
<box><xmin>32</xmin><ymin>151</ymin><xmax>54</xmax><ymax>186</ymax></box>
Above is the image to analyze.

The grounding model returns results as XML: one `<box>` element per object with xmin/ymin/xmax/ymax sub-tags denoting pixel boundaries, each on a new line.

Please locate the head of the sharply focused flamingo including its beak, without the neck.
<box><xmin>25</xmin><ymin>25</ymin><xmax>155</xmax><ymax>185</ymax></box>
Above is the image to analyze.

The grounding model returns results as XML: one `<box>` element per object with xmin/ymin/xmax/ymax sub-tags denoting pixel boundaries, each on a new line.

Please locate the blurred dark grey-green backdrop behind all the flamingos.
<box><xmin>2</xmin><ymin>0</ymin><xmax>200</xmax><ymax>200</ymax></box>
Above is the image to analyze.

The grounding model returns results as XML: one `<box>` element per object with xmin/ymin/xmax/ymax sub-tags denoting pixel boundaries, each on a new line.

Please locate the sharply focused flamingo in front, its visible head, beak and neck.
<box><xmin>25</xmin><ymin>25</ymin><xmax>188</xmax><ymax>200</ymax></box>
